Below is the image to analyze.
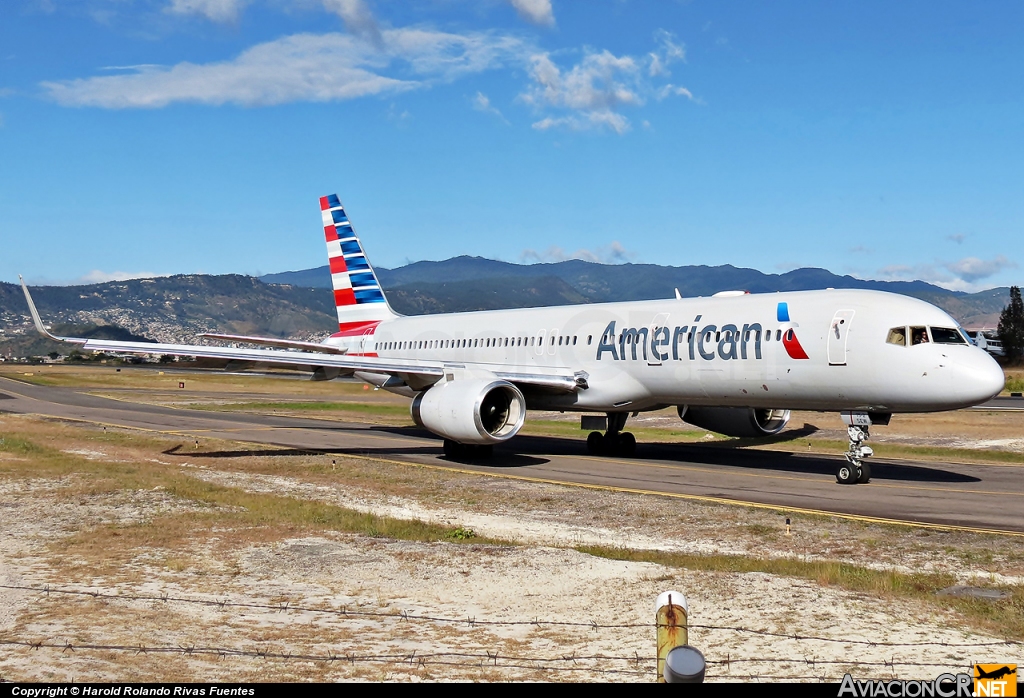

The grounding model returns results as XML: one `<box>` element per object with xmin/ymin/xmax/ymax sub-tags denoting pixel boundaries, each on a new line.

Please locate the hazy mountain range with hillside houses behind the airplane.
<box><xmin>0</xmin><ymin>257</ymin><xmax>1010</xmax><ymax>356</ymax></box>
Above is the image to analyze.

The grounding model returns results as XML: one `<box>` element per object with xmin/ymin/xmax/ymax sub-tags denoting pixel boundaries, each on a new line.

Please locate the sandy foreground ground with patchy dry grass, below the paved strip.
<box><xmin>0</xmin><ymin>397</ymin><xmax>1024</xmax><ymax>682</ymax></box>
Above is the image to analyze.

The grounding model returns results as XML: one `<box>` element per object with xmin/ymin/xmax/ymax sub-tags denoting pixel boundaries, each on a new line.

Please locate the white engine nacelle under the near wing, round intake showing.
<box><xmin>411</xmin><ymin>378</ymin><xmax>526</xmax><ymax>445</ymax></box>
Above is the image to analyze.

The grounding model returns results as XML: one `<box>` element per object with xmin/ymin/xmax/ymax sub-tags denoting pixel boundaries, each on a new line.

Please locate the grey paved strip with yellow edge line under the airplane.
<box><xmin>0</xmin><ymin>378</ymin><xmax>1024</xmax><ymax>534</ymax></box>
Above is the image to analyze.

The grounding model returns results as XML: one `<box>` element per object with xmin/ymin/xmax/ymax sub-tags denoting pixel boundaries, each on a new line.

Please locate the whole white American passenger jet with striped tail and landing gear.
<box><xmin>22</xmin><ymin>194</ymin><xmax>1005</xmax><ymax>484</ymax></box>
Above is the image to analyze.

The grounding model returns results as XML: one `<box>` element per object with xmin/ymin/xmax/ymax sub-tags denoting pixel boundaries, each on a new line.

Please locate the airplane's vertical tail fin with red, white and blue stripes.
<box><xmin>321</xmin><ymin>189</ymin><xmax>397</xmax><ymax>336</ymax></box>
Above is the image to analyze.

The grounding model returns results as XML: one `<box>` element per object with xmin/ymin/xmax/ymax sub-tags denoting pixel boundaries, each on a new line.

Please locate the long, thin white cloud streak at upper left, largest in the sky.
<box><xmin>42</xmin><ymin>29</ymin><xmax>524</xmax><ymax>108</ymax></box>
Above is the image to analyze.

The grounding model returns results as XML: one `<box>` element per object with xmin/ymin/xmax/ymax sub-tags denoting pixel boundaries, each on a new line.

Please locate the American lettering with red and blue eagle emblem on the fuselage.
<box><xmin>597</xmin><ymin>303</ymin><xmax>809</xmax><ymax>362</ymax></box>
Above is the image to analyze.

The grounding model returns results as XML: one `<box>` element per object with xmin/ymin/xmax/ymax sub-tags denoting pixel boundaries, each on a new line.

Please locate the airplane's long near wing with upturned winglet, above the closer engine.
<box><xmin>22</xmin><ymin>279</ymin><xmax>587</xmax><ymax>392</ymax></box>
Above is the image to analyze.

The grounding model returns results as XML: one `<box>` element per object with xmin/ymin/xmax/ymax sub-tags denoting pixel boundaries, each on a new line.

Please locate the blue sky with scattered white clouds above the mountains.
<box><xmin>0</xmin><ymin>0</ymin><xmax>1024</xmax><ymax>291</ymax></box>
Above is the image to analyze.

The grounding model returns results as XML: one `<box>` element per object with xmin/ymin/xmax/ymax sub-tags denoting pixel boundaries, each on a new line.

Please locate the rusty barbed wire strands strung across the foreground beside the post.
<box><xmin>0</xmin><ymin>584</ymin><xmax>1024</xmax><ymax>681</ymax></box>
